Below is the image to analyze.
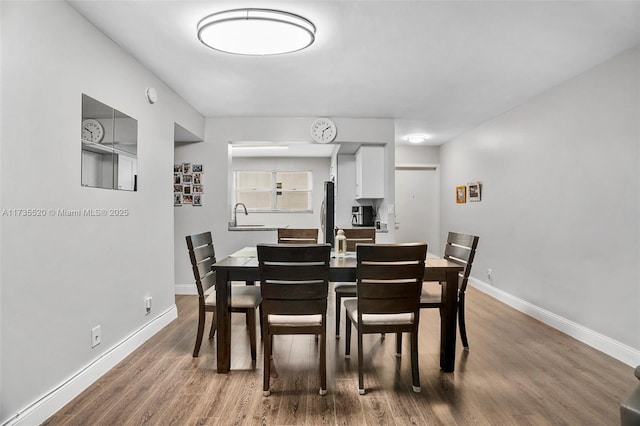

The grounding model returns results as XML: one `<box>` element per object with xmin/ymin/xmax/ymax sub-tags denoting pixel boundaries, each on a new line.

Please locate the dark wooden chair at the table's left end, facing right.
<box><xmin>186</xmin><ymin>232</ymin><xmax>262</xmax><ymax>360</ymax></box>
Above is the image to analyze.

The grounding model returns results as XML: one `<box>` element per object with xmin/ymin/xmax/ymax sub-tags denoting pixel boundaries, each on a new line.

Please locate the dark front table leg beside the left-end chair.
<box><xmin>216</xmin><ymin>271</ymin><xmax>231</xmax><ymax>373</ymax></box>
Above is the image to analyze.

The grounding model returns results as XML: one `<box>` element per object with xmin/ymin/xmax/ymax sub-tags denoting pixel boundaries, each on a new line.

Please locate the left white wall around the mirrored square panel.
<box><xmin>0</xmin><ymin>1</ymin><xmax>204</xmax><ymax>424</ymax></box>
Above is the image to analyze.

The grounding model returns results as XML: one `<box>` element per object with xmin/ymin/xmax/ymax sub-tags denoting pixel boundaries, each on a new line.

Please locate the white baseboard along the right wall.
<box><xmin>469</xmin><ymin>278</ymin><xmax>640</xmax><ymax>367</ymax></box>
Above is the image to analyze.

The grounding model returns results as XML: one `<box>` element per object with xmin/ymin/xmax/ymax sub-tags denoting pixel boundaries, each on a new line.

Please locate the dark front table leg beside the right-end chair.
<box><xmin>440</xmin><ymin>272</ymin><xmax>458</xmax><ymax>373</ymax></box>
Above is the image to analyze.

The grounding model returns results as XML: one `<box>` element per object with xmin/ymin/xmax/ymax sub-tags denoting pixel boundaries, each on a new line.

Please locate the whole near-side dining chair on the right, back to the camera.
<box><xmin>344</xmin><ymin>243</ymin><xmax>427</xmax><ymax>395</ymax></box>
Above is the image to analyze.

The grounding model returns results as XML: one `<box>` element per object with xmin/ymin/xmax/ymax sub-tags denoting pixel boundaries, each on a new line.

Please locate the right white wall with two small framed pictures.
<box><xmin>440</xmin><ymin>49</ymin><xmax>640</xmax><ymax>354</ymax></box>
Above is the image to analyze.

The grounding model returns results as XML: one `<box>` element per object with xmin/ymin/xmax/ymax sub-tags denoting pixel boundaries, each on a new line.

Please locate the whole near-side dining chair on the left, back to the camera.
<box><xmin>257</xmin><ymin>244</ymin><xmax>331</xmax><ymax>396</ymax></box>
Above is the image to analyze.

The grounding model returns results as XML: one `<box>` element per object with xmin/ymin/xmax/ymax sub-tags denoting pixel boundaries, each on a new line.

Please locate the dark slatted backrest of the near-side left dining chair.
<box><xmin>257</xmin><ymin>244</ymin><xmax>331</xmax><ymax>315</ymax></box>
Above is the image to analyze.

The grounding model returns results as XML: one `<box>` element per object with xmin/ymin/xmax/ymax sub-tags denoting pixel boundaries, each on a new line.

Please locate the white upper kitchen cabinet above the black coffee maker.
<box><xmin>356</xmin><ymin>146</ymin><xmax>384</xmax><ymax>199</ymax></box>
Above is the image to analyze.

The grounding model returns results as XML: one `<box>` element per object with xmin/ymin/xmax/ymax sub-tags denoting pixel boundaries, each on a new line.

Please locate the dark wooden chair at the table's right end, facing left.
<box><xmin>420</xmin><ymin>232</ymin><xmax>480</xmax><ymax>350</ymax></box>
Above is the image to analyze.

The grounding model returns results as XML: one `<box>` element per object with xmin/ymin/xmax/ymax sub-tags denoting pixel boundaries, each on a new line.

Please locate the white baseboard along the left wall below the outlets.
<box><xmin>2</xmin><ymin>305</ymin><xmax>178</xmax><ymax>426</ymax></box>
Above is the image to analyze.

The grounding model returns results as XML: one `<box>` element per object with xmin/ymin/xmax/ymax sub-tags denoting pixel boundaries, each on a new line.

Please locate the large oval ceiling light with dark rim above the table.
<box><xmin>197</xmin><ymin>8</ymin><xmax>316</xmax><ymax>55</ymax></box>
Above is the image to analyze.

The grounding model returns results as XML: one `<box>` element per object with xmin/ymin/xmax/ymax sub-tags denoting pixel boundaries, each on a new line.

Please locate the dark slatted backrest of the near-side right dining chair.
<box><xmin>356</xmin><ymin>243</ymin><xmax>427</xmax><ymax>316</ymax></box>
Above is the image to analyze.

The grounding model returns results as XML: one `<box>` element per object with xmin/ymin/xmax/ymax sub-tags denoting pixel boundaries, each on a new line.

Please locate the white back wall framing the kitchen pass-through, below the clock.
<box><xmin>175</xmin><ymin>117</ymin><xmax>395</xmax><ymax>292</ymax></box>
